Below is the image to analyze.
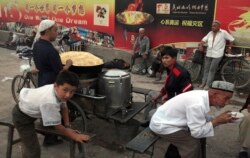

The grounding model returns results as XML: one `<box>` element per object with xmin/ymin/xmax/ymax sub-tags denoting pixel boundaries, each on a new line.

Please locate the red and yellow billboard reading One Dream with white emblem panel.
<box><xmin>0</xmin><ymin>0</ymin><xmax>115</xmax><ymax>35</ymax></box>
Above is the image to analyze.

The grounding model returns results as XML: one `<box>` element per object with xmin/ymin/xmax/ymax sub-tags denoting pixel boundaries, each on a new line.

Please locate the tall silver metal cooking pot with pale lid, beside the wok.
<box><xmin>98</xmin><ymin>69</ymin><xmax>132</xmax><ymax>109</ymax></box>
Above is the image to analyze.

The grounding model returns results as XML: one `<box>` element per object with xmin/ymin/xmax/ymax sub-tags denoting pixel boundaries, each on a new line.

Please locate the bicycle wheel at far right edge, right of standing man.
<box><xmin>221</xmin><ymin>59</ymin><xmax>250</xmax><ymax>88</ymax></box>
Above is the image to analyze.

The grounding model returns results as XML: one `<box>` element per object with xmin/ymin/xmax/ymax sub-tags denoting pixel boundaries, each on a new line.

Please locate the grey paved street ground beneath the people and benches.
<box><xmin>0</xmin><ymin>48</ymin><xmax>249</xmax><ymax>158</ymax></box>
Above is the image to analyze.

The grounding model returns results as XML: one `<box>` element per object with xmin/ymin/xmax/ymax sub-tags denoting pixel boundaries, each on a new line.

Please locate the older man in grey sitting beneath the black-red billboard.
<box><xmin>131</xmin><ymin>28</ymin><xmax>150</xmax><ymax>73</ymax></box>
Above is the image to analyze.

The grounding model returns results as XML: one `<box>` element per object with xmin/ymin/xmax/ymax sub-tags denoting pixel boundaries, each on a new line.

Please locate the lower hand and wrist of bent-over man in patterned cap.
<box><xmin>212</xmin><ymin>111</ymin><xmax>234</xmax><ymax>127</ymax></box>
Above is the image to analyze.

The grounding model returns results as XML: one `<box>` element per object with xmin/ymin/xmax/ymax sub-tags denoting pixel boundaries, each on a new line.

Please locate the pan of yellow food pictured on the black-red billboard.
<box><xmin>116</xmin><ymin>11</ymin><xmax>154</xmax><ymax>26</ymax></box>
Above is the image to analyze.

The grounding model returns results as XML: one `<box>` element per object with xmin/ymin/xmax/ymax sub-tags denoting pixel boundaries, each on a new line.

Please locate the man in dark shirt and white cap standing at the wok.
<box><xmin>33</xmin><ymin>19</ymin><xmax>72</xmax><ymax>146</ymax></box>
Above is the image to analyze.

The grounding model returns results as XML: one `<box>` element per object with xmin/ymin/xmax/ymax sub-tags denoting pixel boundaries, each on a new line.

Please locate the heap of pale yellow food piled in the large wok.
<box><xmin>60</xmin><ymin>51</ymin><xmax>103</xmax><ymax>66</ymax></box>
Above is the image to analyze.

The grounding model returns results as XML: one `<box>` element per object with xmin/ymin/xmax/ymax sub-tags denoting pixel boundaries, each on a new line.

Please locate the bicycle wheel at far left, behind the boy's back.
<box><xmin>11</xmin><ymin>75</ymin><xmax>27</xmax><ymax>104</ymax></box>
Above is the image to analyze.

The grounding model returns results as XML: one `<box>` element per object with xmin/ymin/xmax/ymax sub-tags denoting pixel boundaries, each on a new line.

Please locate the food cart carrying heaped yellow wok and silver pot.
<box><xmin>61</xmin><ymin>52</ymin><xmax>148</xmax><ymax>144</ymax></box>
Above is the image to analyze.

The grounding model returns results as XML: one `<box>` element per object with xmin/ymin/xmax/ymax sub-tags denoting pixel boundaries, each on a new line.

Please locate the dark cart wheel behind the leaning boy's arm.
<box><xmin>67</xmin><ymin>100</ymin><xmax>87</xmax><ymax>158</ymax></box>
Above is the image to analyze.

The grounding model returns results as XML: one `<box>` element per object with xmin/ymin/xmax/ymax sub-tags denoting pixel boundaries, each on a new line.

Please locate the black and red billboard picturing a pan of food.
<box><xmin>115</xmin><ymin>0</ymin><xmax>216</xmax><ymax>49</ymax></box>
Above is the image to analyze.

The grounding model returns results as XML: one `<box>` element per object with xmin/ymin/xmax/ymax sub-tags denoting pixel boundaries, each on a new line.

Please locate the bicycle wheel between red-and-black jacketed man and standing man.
<box><xmin>183</xmin><ymin>59</ymin><xmax>201</xmax><ymax>82</ymax></box>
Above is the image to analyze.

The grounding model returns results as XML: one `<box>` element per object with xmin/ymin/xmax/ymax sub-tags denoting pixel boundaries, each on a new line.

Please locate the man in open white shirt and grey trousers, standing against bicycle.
<box><xmin>199</xmin><ymin>20</ymin><xmax>234</xmax><ymax>90</ymax></box>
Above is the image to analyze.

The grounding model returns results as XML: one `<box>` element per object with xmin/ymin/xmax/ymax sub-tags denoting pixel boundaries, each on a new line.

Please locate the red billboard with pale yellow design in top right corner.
<box><xmin>215</xmin><ymin>0</ymin><xmax>250</xmax><ymax>47</ymax></box>
